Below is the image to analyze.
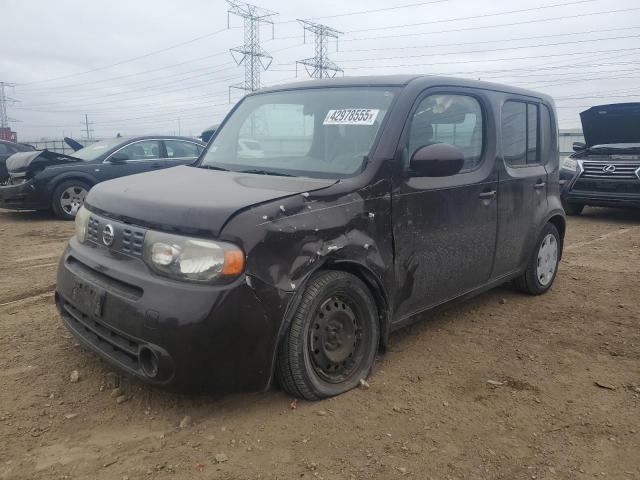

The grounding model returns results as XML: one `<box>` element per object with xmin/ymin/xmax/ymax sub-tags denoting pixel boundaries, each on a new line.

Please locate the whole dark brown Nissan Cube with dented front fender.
<box><xmin>56</xmin><ymin>75</ymin><xmax>565</xmax><ymax>399</ymax></box>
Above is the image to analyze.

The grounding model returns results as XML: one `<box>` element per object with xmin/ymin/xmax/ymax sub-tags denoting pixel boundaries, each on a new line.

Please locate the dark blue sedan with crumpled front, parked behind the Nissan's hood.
<box><xmin>0</xmin><ymin>136</ymin><xmax>204</xmax><ymax>220</ymax></box>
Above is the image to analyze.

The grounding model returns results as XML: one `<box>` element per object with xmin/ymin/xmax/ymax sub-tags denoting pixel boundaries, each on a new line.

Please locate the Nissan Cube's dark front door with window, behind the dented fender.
<box><xmin>392</xmin><ymin>88</ymin><xmax>498</xmax><ymax>320</ymax></box>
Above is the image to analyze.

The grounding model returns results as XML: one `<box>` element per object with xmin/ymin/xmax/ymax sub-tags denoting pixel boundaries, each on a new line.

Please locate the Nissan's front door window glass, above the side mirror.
<box><xmin>407</xmin><ymin>94</ymin><xmax>483</xmax><ymax>171</ymax></box>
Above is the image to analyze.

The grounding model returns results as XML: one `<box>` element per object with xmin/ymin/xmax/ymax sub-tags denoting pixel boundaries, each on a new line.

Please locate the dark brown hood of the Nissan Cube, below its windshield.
<box><xmin>86</xmin><ymin>166</ymin><xmax>336</xmax><ymax>236</ymax></box>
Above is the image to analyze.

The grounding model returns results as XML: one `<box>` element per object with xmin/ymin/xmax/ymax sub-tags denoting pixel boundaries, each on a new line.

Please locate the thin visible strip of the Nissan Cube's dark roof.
<box><xmin>258</xmin><ymin>74</ymin><xmax>553</xmax><ymax>102</ymax></box>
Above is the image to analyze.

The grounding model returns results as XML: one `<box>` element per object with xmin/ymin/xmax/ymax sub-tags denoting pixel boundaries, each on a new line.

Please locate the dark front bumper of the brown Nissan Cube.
<box><xmin>56</xmin><ymin>237</ymin><xmax>289</xmax><ymax>392</ymax></box>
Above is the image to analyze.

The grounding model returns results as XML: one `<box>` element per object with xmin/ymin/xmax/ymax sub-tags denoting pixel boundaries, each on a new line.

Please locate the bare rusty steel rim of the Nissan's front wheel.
<box><xmin>309</xmin><ymin>296</ymin><xmax>363</xmax><ymax>383</ymax></box>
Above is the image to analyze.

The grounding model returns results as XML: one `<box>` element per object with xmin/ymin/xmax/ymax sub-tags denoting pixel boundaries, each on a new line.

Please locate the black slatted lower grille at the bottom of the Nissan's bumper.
<box><xmin>60</xmin><ymin>299</ymin><xmax>140</xmax><ymax>371</ymax></box>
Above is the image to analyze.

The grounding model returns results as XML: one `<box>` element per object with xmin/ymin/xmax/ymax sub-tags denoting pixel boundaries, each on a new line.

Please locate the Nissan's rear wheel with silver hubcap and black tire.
<box><xmin>513</xmin><ymin>223</ymin><xmax>562</xmax><ymax>295</ymax></box>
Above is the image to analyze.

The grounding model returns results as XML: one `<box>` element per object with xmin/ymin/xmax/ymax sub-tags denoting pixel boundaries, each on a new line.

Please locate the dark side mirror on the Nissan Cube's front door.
<box><xmin>409</xmin><ymin>143</ymin><xmax>464</xmax><ymax>177</ymax></box>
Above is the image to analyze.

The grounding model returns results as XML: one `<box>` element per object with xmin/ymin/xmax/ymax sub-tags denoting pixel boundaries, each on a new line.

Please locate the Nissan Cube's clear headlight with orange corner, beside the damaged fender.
<box><xmin>142</xmin><ymin>231</ymin><xmax>244</xmax><ymax>283</ymax></box>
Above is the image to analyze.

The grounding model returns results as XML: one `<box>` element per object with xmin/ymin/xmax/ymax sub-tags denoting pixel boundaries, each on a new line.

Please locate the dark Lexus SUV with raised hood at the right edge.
<box><xmin>560</xmin><ymin>103</ymin><xmax>640</xmax><ymax>215</ymax></box>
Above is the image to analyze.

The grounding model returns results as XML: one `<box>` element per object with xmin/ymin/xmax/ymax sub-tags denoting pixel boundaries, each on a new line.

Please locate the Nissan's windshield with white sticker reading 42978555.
<box><xmin>199</xmin><ymin>87</ymin><xmax>396</xmax><ymax>178</ymax></box>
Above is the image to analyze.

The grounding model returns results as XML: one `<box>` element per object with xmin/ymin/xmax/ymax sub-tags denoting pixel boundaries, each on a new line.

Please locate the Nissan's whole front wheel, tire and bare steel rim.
<box><xmin>276</xmin><ymin>270</ymin><xmax>380</xmax><ymax>400</ymax></box>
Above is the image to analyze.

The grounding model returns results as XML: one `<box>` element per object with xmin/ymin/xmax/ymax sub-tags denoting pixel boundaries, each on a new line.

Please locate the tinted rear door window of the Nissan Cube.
<box><xmin>502</xmin><ymin>100</ymin><xmax>540</xmax><ymax>167</ymax></box>
